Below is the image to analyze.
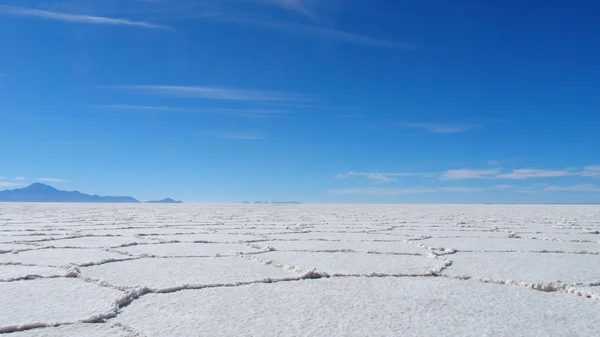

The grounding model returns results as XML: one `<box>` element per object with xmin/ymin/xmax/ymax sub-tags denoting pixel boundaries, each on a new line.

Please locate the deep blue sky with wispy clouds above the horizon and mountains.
<box><xmin>0</xmin><ymin>0</ymin><xmax>600</xmax><ymax>203</ymax></box>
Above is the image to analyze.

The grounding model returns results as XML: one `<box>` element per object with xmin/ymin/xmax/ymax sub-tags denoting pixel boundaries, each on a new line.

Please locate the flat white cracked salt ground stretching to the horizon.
<box><xmin>0</xmin><ymin>204</ymin><xmax>600</xmax><ymax>337</ymax></box>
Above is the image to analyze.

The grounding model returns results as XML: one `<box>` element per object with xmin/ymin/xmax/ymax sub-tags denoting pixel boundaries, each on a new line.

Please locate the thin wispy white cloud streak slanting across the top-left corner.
<box><xmin>0</xmin><ymin>5</ymin><xmax>172</xmax><ymax>29</ymax></box>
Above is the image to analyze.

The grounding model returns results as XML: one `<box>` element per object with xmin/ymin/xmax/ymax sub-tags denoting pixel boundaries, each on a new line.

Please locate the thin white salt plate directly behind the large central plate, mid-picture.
<box><xmin>253</xmin><ymin>240</ymin><xmax>430</xmax><ymax>255</ymax></box>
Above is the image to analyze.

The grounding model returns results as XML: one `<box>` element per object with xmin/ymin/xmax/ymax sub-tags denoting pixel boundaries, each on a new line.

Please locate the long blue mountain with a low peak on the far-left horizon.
<box><xmin>0</xmin><ymin>183</ymin><xmax>139</xmax><ymax>203</ymax></box>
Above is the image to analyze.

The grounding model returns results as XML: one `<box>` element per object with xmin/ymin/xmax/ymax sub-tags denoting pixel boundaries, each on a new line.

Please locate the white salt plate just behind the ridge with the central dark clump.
<box><xmin>248</xmin><ymin>251</ymin><xmax>445</xmax><ymax>275</ymax></box>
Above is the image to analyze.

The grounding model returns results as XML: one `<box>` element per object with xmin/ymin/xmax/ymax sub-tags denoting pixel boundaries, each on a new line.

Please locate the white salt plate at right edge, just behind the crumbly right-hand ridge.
<box><xmin>444</xmin><ymin>252</ymin><xmax>600</xmax><ymax>284</ymax></box>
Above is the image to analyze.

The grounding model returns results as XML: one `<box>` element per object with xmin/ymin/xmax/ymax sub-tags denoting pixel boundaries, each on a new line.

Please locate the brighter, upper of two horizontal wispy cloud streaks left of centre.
<box><xmin>116</xmin><ymin>85</ymin><xmax>314</xmax><ymax>102</ymax></box>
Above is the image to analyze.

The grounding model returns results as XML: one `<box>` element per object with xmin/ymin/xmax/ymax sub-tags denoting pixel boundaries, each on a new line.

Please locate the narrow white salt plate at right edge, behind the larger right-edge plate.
<box><xmin>415</xmin><ymin>238</ymin><xmax>600</xmax><ymax>253</ymax></box>
